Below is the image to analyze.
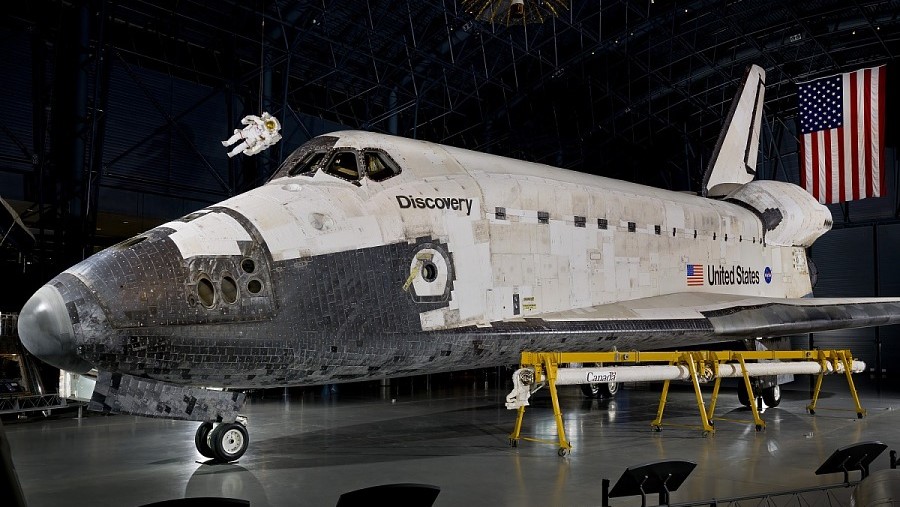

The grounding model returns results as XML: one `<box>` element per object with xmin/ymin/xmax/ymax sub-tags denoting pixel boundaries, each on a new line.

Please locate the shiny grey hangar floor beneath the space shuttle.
<box><xmin>4</xmin><ymin>370</ymin><xmax>900</xmax><ymax>507</ymax></box>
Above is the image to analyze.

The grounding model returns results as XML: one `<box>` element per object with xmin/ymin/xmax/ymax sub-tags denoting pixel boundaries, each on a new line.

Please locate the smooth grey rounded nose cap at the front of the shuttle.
<box><xmin>18</xmin><ymin>285</ymin><xmax>91</xmax><ymax>373</ymax></box>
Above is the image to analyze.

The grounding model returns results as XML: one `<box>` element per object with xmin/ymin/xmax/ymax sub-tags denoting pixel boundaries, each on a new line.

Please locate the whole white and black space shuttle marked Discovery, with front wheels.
<box><xmin>18</xmin><ymin>67</ymin><xmax>900</xmax><ymax>461</ymax></box>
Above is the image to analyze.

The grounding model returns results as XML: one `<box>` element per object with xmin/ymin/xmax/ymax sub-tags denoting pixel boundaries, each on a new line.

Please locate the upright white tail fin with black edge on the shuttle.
<box><xmin>703</xmin><ymin>65</ymin><xmax>766</xmax><ymax>197</ymax></box>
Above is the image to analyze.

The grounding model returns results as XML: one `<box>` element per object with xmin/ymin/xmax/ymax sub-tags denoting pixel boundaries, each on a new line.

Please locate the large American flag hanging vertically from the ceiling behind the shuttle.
<box><xmin>797</xmin><ymin>66</ymin><xmax>886</xmax><ymax>204</ymax></box>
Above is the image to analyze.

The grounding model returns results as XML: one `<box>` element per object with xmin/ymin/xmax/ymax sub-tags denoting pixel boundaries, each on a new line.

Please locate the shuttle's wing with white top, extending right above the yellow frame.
<box><xmin>524</xmin><ymin>293</ymin><xmax>900</xmax><ymax>339</ymax></box>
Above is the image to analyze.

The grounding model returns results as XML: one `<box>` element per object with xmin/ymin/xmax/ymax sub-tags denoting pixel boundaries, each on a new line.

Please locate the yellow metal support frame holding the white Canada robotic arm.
<box><xmin>509</xmin><ymin>350</ymin><xmax>866</xmax><ymax>456</ymax></box>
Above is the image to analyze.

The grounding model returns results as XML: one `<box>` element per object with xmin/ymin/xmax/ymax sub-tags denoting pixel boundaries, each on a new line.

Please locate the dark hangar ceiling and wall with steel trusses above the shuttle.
<box><xmin>0</xmin><ymin>0</ymin><xmax>900</xmax><ymax>306</ymax></box>
